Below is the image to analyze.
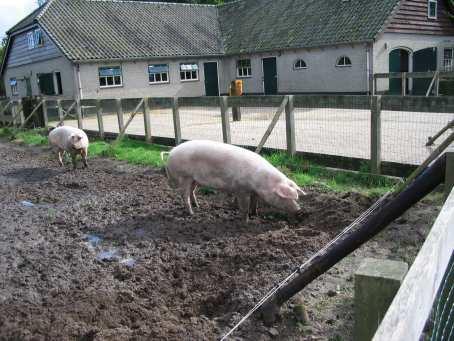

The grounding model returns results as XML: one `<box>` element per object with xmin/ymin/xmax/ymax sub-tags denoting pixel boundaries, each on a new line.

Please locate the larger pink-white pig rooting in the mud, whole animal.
<box><xmin>166</xmin><ymin>140</ymin><xmax>305</xmax><ymax>221</ymax></box>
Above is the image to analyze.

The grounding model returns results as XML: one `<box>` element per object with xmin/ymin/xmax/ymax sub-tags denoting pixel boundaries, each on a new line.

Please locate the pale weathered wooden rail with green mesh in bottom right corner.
<box><xmin>373</xmin><ymin>175</ymin><xmax>454</xmax><ymax>341</ymax></box>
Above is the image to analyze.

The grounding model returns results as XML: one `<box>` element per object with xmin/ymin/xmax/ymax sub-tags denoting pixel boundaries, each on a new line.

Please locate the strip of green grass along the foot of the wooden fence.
<box><xmin>0</xmin><ymin>128</ymin><xmax>396</xmax><ymax>196</ymax></box>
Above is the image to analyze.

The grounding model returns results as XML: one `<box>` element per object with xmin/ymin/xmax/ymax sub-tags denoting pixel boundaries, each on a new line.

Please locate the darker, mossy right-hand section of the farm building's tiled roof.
<box><xmin>219</xmin><ymin>0</ymin><xmax>399</xmax><ymax>54</ymax></box>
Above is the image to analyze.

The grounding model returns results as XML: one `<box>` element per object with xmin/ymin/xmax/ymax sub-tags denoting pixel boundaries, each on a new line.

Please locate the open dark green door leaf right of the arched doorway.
<box><xmin>413</xmin><ymin>47</ymin><xmax>437</xmax><ymax>96</ymax></box>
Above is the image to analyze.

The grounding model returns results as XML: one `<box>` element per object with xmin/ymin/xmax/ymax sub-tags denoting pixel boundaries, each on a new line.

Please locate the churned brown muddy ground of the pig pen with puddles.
<box><xmin>0</xmin><ymin>142</ymin><xmax>439</xmax><ymax>340</ymax></box>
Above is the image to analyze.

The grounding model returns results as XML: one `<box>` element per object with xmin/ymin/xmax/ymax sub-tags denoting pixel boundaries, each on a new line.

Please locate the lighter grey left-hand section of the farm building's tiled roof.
<box><xmin>38</xmin><ymin>0</ymin><xmax>223</xmax><ymax>60</ymax></box>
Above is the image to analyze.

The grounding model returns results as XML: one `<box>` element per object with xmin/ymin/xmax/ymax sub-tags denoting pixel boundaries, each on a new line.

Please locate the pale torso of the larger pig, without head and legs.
<box><xmin>167</xmin><ymin>140</ymin><xmax>279</xmax><ymax>190</ymax></box>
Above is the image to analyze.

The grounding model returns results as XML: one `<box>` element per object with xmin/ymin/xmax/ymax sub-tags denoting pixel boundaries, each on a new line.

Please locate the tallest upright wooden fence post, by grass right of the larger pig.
<box><xmin>370</xmin><ymin>96</ymin><xmax>381</xmax><ymax>174</ymax></box>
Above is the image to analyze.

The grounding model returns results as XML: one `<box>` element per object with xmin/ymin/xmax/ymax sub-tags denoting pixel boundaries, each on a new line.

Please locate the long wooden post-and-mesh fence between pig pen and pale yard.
<box><xmin>0</xmin><ymin>95</ymin><xmax>454</xmax><ymax>175</ymax></box>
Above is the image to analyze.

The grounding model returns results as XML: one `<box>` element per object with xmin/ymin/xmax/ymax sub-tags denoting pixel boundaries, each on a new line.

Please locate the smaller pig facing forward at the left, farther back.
<box><xmin>49</xmin><ymin>126</ymin><xmax>88</xmax><ymax>169</ymax></box>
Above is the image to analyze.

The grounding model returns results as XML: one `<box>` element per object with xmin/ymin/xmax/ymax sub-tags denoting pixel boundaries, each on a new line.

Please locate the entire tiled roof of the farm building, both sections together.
<box><xmin>6</xmin><ymin>0</ymin><xmax>399</xmax><ymax>61</ymax></box>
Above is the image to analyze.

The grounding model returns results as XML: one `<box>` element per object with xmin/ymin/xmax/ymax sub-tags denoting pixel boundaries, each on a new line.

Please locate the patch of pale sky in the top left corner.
<box><xmin>0</xmin><ymin>0</ymin><xmax>38</xmax><ymax>38</ymax></box>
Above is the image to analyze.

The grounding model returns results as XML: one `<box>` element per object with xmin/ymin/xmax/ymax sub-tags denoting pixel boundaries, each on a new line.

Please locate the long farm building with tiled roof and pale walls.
<box><xmin>1</xmin><ymin>0</ymin><xmax>454</xmax><ymax>99</ymax></box>
